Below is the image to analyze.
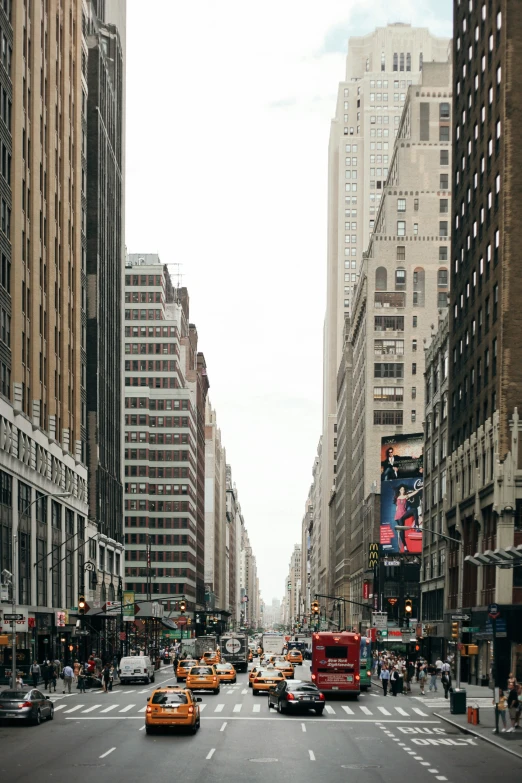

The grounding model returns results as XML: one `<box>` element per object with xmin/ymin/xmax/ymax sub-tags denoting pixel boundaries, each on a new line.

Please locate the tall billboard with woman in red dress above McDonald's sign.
<box><xmin>380</xmin><ymin>433</ymin><xmax>424</xmax><ymax>555</ymax></box>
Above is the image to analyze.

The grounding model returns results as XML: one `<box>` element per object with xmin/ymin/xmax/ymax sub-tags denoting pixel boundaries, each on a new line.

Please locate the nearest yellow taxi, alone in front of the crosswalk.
<box><xmin>145</xmin><ymin>685</ymin><xmax>201</xmax><ymax>734</ymax></box>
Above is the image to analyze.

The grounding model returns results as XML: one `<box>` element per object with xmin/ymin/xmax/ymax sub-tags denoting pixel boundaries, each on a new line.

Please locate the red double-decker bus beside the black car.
<box><xmin>311</xmin><ymin>631</ymin><xmax>361</xmax><ymax>698</ymax></box>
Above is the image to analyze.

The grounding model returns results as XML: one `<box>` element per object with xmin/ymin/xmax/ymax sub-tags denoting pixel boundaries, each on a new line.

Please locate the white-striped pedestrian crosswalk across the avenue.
<box><xmin>50</xmin><ymin>690</ymin><xmax>430</xmax><ymax>721</ymax></box>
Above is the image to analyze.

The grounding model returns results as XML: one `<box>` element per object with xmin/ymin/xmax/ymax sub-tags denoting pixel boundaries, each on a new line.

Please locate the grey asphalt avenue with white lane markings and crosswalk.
<box><xmin>0</xmin><ymin>664</ymin><xmax>512</xmax><ymax>783</ymax></box>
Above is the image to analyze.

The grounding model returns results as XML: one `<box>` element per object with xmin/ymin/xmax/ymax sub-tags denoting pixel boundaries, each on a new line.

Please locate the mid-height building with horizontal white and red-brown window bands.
<box><xmin>124</xmin><ymin>254</ymin><xmax>208</xmax><ymax>612</ymax></box>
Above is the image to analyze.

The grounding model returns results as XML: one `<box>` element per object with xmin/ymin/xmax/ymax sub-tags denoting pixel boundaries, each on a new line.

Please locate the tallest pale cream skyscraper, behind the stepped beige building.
<box><xmin>315</xmin><ymin>24</ymin><xmax>449</xmax><ymax>593</ymax></box>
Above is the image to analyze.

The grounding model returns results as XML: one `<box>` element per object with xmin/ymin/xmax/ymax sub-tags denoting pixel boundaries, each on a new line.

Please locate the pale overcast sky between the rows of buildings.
<box><xmin>126</xmin><ymin>0</ymin><xmax>452</xmax><ymax>602</ymax></box>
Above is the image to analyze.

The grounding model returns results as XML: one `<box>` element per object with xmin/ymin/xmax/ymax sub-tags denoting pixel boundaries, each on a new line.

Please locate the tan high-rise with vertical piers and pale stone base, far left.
<box><xmin>0</xmin><ymin>0</ymin><xmax>102</xmax><ymax>658</ymax></box>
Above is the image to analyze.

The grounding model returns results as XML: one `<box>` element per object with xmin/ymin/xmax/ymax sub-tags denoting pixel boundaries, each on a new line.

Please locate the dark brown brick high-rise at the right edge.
<box><xmin>445</xmin><ymin>0</ymin><xmax>522</xmax><ymax>686</ymax></box>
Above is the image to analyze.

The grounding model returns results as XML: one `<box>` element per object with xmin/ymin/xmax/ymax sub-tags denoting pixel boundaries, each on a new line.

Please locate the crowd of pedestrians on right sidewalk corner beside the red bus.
<box><xmin>373</xmin><ymin>651</ymin><xmax>453</xmax><ymax>699</ymax></box>
